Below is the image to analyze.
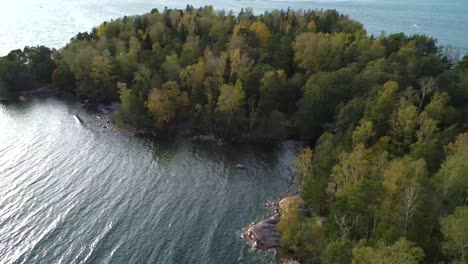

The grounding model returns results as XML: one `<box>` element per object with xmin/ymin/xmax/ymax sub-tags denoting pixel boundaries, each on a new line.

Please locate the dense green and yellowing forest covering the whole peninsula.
<box><xmin>0</xmin><ymin>6</ymin><xmax>468</xmax><ymax>264</ymax></box>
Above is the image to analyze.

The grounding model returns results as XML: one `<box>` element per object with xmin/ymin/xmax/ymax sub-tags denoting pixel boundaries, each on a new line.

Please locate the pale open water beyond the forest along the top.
<box><xmin>0</xmin><ymin>0</ymin><xmax>468</xmax><ymax>55</ymax></box>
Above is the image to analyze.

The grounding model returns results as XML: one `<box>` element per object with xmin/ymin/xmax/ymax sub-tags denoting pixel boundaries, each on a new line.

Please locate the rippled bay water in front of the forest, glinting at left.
<box><xmin>0</xmin><ymin>99</ymin><xmax>298</xmax><ymax>264</ymax></box>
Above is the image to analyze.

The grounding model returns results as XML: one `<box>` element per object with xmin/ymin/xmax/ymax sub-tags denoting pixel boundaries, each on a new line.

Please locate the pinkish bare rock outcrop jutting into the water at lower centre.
<box><xmin>242</xmin><ymin>216</ymin><xmax>280</xmax><ymax>250</ymax></box>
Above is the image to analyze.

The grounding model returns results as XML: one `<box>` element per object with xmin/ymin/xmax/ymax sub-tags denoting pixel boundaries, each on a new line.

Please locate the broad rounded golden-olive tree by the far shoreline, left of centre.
<box><xmin>146</xmin><ymin>81</ymin><xmax>190</xmax><ymax>126</ymax></box>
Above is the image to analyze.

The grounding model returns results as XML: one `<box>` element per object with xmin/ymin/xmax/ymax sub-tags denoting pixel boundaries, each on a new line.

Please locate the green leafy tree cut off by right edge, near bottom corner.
<box><xmin>441</xmin><ymin>206</ymin><xmax>468</xmax><ymax>263</ymax></box>
